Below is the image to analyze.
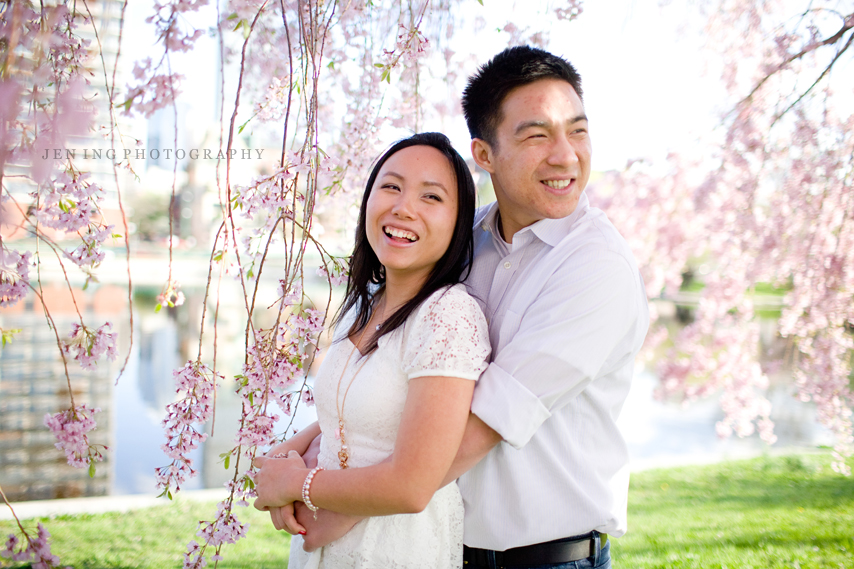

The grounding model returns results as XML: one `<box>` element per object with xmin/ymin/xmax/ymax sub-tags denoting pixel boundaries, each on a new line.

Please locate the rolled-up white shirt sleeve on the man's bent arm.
<box><xmin>472</xmin><ymin>247</ymin><xmax>640</xmax><ymax>449</ymax></box>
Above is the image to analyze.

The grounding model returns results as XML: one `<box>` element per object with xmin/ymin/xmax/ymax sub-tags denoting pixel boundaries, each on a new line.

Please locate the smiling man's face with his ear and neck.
<box><xmin>472</xmin><ymin>79</ymin><xmax>592</xmax><ymax>242</ymax></box>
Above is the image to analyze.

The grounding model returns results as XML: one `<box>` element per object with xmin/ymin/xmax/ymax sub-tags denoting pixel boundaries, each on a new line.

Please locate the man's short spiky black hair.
<box><xmin>463</xmin><ymin>45</ymin><xmax>582</xmax><ymax>146</ymax></box>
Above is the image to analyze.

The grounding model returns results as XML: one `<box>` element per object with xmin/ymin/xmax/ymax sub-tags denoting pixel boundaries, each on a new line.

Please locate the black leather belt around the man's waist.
<box><xmin>463</xmin><ymin>533</ymin><xmax>608</xmax><ymax>567</ymax></box>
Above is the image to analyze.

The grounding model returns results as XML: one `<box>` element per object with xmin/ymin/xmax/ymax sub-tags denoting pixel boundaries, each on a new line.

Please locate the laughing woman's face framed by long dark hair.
<box><xmin>365</xmin><ymin>146</ymin><xmax>457</xmax><ymax>282</ymax></box>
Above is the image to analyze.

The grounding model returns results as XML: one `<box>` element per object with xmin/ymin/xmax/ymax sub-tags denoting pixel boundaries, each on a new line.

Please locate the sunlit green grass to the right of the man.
<box><xmin>614</xmin><ymin>453</ymin><xmax>854</xmax><ymax>569</ymax></box>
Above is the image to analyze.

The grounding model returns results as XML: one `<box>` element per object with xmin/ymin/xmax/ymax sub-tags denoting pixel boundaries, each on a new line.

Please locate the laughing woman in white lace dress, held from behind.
<box><xmin>255</xmin><ymin>133</ymin><xmax>490</xmax><ymax>569</ymax></box>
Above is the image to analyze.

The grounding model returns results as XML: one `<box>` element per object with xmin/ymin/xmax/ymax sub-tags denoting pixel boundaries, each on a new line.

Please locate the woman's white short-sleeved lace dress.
<box><xmin>289</xmin><ymin>285</ymin><xmax>490</xmax><ymax>569</ymax></box>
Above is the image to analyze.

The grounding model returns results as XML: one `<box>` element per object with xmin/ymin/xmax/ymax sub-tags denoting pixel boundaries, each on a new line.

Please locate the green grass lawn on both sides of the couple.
<box><xmin>0</xmin><ymin>453</ymin><xmax>854</xmax><ymax>569</ymax></box>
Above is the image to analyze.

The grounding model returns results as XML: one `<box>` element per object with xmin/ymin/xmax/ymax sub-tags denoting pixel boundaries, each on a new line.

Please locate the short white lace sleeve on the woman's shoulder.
<box><xmin>403</xmin><ymin>285</ymin><xmax>491</xmax><ymax>379</ymax></box>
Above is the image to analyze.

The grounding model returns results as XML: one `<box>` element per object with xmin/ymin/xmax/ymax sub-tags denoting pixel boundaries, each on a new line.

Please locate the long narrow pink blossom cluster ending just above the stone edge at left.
<box><xmin>155</xmin><ymin>361</ymin><xmax>223</xmax><ymax>498</ymax></box>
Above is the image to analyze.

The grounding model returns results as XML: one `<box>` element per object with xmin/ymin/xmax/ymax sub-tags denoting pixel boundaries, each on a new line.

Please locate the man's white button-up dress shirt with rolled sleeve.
<box><xmin>458</xmin><ymin>194</ymin><xmax>649</xmax><ymax>551</ymax></box>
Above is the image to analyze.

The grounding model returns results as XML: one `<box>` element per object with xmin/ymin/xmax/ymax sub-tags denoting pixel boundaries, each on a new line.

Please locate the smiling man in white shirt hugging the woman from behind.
<box><xmin>449</xmin><ymin>47</ymin><xmax>649</xmax><ymax>568</ymax></box>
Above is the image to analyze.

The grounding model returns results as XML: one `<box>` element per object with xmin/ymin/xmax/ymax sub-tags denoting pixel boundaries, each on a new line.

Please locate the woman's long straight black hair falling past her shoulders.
<box><xmin>335</xmin><ymin>132</ymin><xmax>476</xmax><ymax>354</ymax></box>
